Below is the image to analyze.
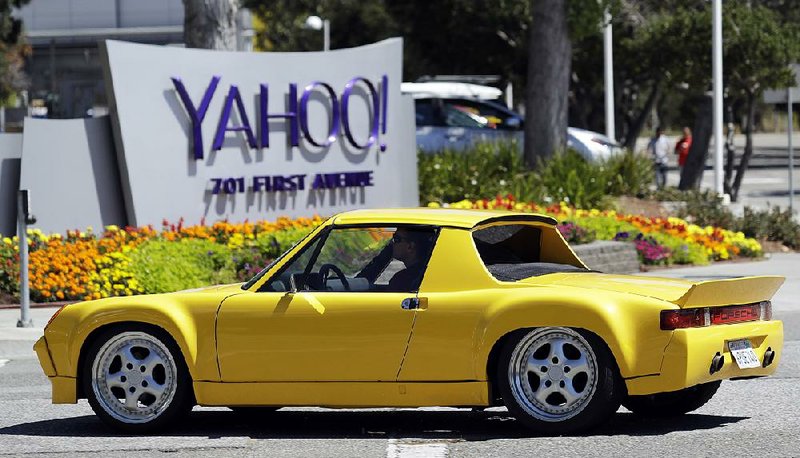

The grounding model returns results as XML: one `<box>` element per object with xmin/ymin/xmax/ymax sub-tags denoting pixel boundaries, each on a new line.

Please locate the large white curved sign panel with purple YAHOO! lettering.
<box><xmin>103</xmin><ymin>38</ymin><xmax>418</xmax><ymax>226</ymax></box>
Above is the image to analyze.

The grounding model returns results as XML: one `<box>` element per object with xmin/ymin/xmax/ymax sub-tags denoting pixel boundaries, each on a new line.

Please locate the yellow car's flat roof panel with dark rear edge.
<box><xmin>333</xmin><ymin>208</ymin><xmax>557</xmax><ymax>229</ymax></box>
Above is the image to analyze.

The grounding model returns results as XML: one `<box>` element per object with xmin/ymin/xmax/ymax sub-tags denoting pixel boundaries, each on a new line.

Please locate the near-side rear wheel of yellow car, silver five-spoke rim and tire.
<box><xmin>496</xmin><ymin>327</ymin><xmax>625</xmax><ymax>435</ymax></box>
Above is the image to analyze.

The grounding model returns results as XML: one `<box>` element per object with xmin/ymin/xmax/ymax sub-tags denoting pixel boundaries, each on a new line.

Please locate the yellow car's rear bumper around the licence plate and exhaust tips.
<box><xmin>625</xmin><ymin>320</ymin><xmax>783</xmax><ymax>395</ymax></box>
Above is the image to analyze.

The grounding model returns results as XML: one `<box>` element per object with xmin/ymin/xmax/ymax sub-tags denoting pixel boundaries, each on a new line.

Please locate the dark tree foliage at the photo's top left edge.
<box><xmin>0</xmin><ymin>0</ymin><xmax>30</xmax><ymax>105</ymax></box>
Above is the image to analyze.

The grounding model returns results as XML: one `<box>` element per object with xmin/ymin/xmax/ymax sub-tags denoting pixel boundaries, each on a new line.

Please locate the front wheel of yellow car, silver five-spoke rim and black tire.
<box><xmin>81</xmin><ymin>325</ymin><xmax>194</xmax><ymax>433</ymax></box>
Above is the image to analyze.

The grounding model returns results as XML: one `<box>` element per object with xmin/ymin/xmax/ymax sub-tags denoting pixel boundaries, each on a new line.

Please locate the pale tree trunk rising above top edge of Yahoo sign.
<box><xmin>183</xmin><ymin>0</ymin><xmax>239</xmax><ymax>51</ymax></box>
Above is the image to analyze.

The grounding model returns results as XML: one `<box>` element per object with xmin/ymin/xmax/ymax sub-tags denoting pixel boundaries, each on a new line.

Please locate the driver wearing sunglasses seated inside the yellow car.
<box><xmin>388</xmin><ymin>228</ymin><xmax>431</xmax><ymax>292</ymax></box>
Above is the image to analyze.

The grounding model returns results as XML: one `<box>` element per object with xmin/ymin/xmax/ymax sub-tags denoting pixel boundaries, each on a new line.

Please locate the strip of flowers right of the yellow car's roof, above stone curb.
<box><xmin>429</xmin><ymin>195</ymin><xmax>763</xmax><ymax>265</ymax></box>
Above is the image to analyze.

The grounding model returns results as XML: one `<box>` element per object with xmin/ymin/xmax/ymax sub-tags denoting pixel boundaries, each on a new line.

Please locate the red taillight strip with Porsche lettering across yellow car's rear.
<box><xmin>661</xmin><ymin>301</ymin><xmax>772</xmax><ymax>331</ymax></box>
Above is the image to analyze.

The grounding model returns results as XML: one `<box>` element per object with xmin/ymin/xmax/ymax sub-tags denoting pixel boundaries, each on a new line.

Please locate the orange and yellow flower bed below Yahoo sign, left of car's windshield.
<box><xmin>0</xmin><ymin>217</ymin><xmax>323</xmax><ymax>302</ymax></box>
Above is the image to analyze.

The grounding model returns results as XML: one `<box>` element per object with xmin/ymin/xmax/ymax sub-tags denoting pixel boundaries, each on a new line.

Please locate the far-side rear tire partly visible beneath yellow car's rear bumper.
<box><xmin>622</xmin><ymin>381</ymin><xmax>722</xmax><ymax>417</ymax></box>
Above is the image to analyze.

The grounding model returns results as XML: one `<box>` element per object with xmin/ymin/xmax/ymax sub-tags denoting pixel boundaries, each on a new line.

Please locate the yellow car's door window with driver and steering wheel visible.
<box><xmin>265</xmin><ymin>226</ymin><xmax>436</xmax><ymax>292</ymax></box>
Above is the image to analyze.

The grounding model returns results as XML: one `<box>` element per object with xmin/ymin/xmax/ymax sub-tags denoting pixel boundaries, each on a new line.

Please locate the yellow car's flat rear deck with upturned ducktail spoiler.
<box><xmin>520</xmin><ymin>272</ymin><xmax>785</xmax><ymax>307</ymax></box>
